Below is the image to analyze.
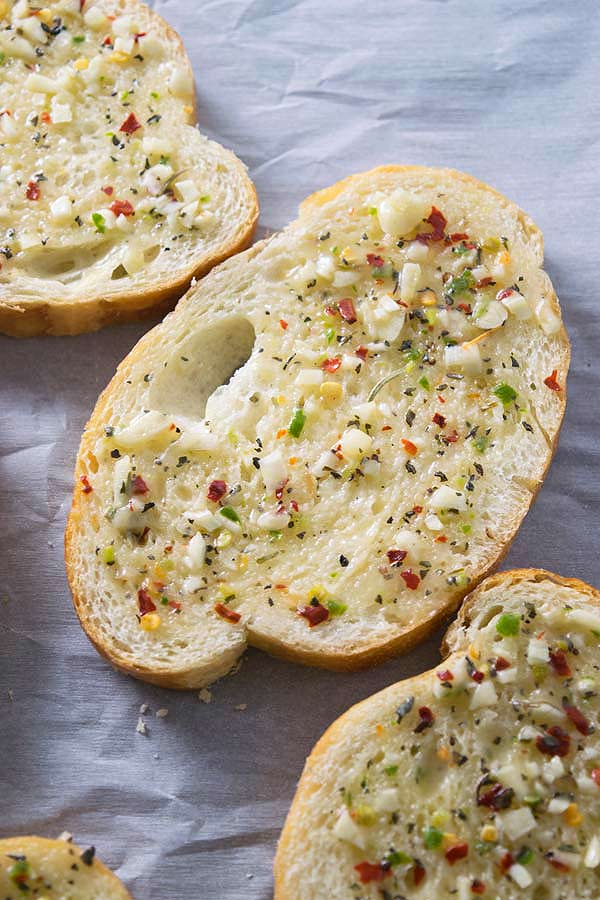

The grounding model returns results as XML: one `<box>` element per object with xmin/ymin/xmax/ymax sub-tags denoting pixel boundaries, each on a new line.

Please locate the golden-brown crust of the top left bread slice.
<box><xmin>0</xmin><ymin>0</ymin><xmax>259</xmax><ymax>337</ymax></box>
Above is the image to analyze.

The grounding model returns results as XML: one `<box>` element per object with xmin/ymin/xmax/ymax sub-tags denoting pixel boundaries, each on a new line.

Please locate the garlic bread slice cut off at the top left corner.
<box><xmin>0</xmin><ymin>0</ymin><xmax>258</xmax><ymax>337</ymax></box>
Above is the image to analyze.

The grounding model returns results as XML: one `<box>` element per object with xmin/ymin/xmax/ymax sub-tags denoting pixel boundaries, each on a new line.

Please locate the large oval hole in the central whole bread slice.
<box><xmin>149</xmin><ymin>315</ymin><xmax>256</xmax><ymax>419</ymax></box>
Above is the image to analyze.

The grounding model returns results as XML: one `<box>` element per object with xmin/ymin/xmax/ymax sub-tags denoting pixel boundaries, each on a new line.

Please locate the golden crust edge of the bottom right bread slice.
<box><xmin>273</xmin><ymin>569</ymin><xmax>600</xmax><ymax>900</ymax></box>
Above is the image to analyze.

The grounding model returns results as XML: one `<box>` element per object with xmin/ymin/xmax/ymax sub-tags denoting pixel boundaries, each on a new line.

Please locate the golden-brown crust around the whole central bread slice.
<box><xmin>65</xmin><ymin>166</ymin><xmax>570</xmax><ymax>690</ymax></box>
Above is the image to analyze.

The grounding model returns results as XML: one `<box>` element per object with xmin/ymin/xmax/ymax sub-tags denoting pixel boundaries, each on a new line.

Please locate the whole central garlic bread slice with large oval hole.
<box><xmin>66</xmin><ymin>167</ymin><xmax>569</xmax><ymax>688</ymax></box>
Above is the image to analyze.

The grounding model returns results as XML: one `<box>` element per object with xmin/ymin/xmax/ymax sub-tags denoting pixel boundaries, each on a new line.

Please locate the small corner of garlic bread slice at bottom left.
<box><xmin>0</xmin><ymin>836</ymin><xmax>131</xmax><ymax>900</ymax></box>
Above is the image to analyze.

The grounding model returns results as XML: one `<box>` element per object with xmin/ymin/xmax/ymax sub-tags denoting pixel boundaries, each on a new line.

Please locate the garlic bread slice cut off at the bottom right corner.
<box><xmin>275</xmin><ymin>569</ymin><xmax>600</xmax><ymax>900</ymax></box>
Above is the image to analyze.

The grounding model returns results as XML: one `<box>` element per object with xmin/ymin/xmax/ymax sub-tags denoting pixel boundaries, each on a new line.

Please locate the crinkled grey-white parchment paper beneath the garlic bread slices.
<box><xmin>0</xmin><ymin>0</ymin><xmax>600</xmax><ymax>900</ymax></box>
